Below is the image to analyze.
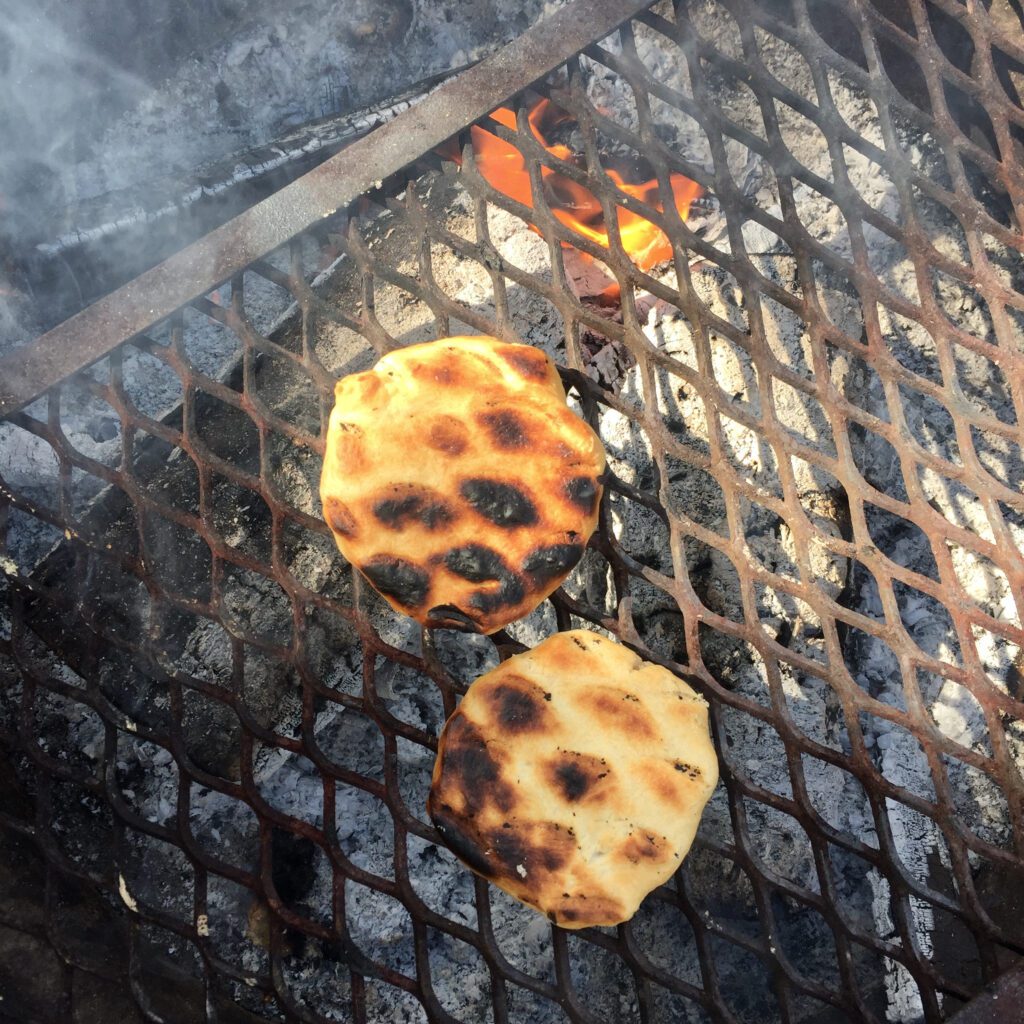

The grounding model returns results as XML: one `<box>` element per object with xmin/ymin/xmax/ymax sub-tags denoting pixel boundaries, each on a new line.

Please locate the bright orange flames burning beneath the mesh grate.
<box><xmin>470</xmin><ymin>99</ymin><xmax>703</xmax><ymax>270</ymax></box>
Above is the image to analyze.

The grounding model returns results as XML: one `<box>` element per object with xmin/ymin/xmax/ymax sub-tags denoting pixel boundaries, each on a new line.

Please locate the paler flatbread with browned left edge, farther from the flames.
<box><xmin>427</xmin><ymin>630</ymin><xmax>718</xmax><ymax>928</ymax></box>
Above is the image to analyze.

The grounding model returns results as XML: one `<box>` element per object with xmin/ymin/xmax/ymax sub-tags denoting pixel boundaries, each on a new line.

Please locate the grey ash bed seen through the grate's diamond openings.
<box><xmin>0</xmin><ymin>0</ymin><xmax>1024</xmax><ymax>1024</ymax></box>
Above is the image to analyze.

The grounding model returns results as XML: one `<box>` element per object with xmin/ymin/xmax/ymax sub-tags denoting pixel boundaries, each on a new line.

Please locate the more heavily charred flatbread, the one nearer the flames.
<box><xmin>321</xmin><ymin>337</ymin><xmax>604</xmax><ymax>633</ymax></box>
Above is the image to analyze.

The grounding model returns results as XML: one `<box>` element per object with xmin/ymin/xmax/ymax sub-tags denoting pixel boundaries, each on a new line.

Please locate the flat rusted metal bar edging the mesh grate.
<box><xmin>0</xmin><ymin>0</ymin><xmax>646</xmax><ymax>416</ymax></box>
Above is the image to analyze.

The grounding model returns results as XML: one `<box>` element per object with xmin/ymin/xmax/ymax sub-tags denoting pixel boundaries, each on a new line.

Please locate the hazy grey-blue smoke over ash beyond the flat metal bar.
<box><xmin>0</xmin><ymin>0</ymin><xmax>562</xmax><ymax>352</ymax></box>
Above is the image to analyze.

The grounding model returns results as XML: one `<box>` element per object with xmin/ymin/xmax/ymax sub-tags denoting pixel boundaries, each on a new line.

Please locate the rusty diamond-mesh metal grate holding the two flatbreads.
<box><xmin>0</xmin><ymin>0</ymin><xmax>1024</xmax><ymax>1022</ymax></box>
